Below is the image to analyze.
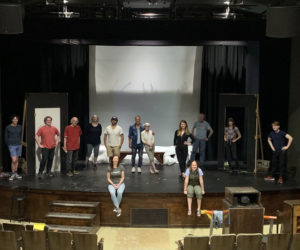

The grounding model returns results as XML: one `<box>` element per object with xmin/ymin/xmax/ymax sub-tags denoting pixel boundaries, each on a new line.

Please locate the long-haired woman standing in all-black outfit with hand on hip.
<box><xmin>174</xmin><ymin>120</ymin><xmax>194</xmax><ymax>178</ymax></box>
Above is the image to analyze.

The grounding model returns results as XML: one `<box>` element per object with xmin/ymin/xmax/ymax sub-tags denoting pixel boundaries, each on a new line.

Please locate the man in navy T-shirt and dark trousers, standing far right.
<box><xmin>265</xmin><ymin>121</ymin><xmax>293</xmax><ymax>184</ymax></box>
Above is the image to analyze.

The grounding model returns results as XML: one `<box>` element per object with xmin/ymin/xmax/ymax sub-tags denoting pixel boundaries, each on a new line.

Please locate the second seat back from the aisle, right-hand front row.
<box><xmin>210</xmin><ymin>234</ymin><xmax>236</xmax><ymax>250</ymax></box>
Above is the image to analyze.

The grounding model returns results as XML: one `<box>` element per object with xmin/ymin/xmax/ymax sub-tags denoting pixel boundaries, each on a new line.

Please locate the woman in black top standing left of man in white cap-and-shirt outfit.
<box><xmin>85</xmin><ymin>115</ymin><xmax>102</xmax><ymax>167</ymax></box>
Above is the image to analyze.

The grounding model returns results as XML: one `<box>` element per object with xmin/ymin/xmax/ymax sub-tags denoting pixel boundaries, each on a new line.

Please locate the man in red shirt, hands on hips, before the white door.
<box><xmin>35</xmin><ymin>116</ymin><xmax>60</xmax><ymax>179</ymax></box>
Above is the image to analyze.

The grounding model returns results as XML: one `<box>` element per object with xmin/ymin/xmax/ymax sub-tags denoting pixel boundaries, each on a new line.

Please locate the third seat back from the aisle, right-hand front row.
<box><xmin>236</xmin><ymin>234</ymin><xmax>262</xmax><ymax>250</ymax></box>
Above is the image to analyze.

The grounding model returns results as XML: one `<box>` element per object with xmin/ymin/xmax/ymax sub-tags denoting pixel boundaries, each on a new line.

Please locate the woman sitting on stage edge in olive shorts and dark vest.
<box><xmin>184</xmin><ymin>161</ymin><xmax>205</xmax><ymax>217</ymax></box>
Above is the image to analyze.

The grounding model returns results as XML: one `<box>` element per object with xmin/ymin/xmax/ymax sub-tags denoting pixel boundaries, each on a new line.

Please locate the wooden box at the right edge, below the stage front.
<box><xmin>280</xmin><ymin>200</ymin><xmax>300</xmax><ymax>234</ymax></box>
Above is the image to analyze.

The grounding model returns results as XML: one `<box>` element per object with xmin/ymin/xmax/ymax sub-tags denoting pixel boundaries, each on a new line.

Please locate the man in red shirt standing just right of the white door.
<box><xmin>63</xmin><ymin>117</ymin><xmax>82</xmax><ymax>176</ymax></box>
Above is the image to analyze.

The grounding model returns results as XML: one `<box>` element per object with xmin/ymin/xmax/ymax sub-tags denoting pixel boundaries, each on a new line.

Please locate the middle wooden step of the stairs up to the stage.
<box><xmin>45</xmin><ymin>212</ymin><xmax>96</xmax><ymax>226</ymax></box>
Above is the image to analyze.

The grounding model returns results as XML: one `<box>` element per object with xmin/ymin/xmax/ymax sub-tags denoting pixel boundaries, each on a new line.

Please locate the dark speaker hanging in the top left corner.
<box><xmin>0</xmin><ymin>2</ymin><xmax>23</xmax><ymax>34</ymax></box>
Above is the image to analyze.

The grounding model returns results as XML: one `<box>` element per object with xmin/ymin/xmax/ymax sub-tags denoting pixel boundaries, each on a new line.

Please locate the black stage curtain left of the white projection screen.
<box><xmin>0</xmin><ymin>42</ymin><xmax>89</xmax><ymax>170</ymax></box>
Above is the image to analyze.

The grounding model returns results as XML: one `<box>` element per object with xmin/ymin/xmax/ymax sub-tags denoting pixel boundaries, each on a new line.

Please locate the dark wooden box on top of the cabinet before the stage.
<box><xmin>225</xmin><ymin>187</ymin><xmax>261</xmax><ymax>206</ymax></box>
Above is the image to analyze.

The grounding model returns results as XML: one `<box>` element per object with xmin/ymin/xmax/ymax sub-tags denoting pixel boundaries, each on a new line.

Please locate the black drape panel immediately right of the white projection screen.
<box><xmin>200</xmin><ymin>45</ymin><xmax>247</xmax><ymax>160</ymax></box>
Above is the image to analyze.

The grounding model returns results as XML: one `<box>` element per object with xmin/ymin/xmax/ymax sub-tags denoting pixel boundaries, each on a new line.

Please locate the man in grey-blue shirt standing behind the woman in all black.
<box><xmin>190</xmin><ymin>113</ymin><xmax>214</xmax><ymax>164</ymax></box>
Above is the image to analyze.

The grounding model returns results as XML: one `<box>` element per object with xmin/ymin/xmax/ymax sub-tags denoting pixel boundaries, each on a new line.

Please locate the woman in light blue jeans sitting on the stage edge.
<box><xmin>106</xmin><ymin>156</ymin><xmax>125</xmax><ymax>217</ymax></box>
